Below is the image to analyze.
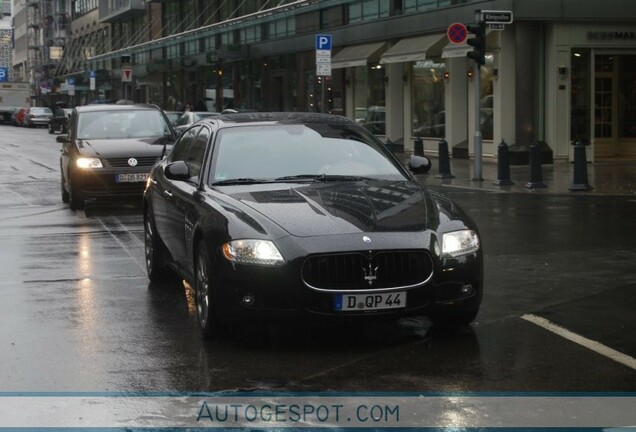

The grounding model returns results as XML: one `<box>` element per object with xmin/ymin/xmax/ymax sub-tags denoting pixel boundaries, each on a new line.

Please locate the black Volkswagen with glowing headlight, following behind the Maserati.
<box><xmin>57</xmin><ymin>104</ymin><xmax>176</xmax><ymax>210</ymax></box>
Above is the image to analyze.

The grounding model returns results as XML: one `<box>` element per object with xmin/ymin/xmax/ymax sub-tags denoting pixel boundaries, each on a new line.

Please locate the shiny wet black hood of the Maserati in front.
<box><xmin>223</xmin><ymin>181</ymin><xmax>430</xmax><ymax>237</ymax></box>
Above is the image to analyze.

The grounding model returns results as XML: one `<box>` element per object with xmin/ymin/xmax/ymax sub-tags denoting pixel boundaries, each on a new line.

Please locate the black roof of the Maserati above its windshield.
<box><xmin>199</xmin><ymin>112</ymin><xmax>357</xmax><ymax>127</ymax></box>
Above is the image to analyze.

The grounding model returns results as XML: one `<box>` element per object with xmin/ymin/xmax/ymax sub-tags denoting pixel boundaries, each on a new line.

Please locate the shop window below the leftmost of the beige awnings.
<box><xmin>353</xmin><ymin>64</ymin><xmax>386</xmax><ymax>135</ymax></box>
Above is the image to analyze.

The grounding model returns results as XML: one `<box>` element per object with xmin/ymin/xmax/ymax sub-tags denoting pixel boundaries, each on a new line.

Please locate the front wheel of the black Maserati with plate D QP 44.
<box><xmin>194</xmin><ymin>242</ymin><xmax>220</xmax><ymax>339</ymax></box>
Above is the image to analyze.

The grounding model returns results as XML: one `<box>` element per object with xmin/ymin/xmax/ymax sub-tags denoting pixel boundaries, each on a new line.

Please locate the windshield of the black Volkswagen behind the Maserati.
<box><xmin>77</xmin><ymin>110</ymin><xmax>170</xmax><ymax>139</ymax></box>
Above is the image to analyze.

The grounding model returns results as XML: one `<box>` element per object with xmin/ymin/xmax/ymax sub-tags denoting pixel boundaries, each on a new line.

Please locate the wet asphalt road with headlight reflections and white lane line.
<box><xmin>0</xmin><ymin>126</ymin><xmax>636</xmax><ymax>392</ymax></box>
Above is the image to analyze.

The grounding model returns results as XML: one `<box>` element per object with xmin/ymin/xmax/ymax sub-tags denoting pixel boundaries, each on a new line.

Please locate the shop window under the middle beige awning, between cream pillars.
<box><xmin>411</xmin><ymin>60</ymin><xmax>446</xmax><ymax>137</ymax></box>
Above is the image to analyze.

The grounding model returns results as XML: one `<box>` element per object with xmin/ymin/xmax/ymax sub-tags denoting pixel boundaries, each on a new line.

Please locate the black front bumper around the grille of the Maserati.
<box><xmin>213</xmin><ymin>250</ymin><xmax>482</xmax><ymax>320</ymax></box>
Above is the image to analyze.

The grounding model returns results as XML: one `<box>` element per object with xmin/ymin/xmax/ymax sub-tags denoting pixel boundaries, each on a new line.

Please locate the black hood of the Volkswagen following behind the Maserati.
<box><xmin>77</xmin><ymin>137</ymin><xmax>173</xmax><ymax>157</ymax></box>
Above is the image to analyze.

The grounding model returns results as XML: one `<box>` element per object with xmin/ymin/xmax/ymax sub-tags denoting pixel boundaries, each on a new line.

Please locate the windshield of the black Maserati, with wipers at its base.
<box><xmin>212</xmin><ymin>123</ymin><xmax>406</xmax><ymax>183</ymax></box>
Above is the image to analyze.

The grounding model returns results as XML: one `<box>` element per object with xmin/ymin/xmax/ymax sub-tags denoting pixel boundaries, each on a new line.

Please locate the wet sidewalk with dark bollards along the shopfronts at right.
<box><xmin>410</xmin><ymin>155</ymin><xmax>636</xmax><ymax>195</ymax></box>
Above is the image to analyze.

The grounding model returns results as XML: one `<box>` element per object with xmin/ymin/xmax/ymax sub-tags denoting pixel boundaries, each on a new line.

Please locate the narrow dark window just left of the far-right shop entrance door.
<box><xmin>570</xmin><ymin>48</ymin><xmax>592</xmax><ymax>143</ymax></box>
